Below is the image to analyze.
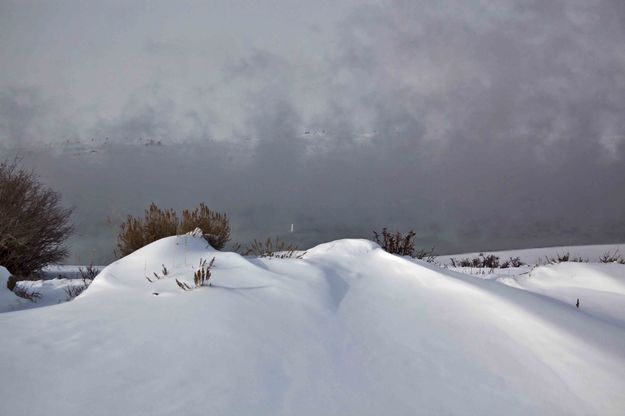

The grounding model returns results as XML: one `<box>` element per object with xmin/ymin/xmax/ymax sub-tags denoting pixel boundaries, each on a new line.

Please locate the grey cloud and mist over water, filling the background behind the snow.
<box><xmin>0</xmin><ymin>0</ymin><xmax>625</xmax><ymax>262</ymax></box>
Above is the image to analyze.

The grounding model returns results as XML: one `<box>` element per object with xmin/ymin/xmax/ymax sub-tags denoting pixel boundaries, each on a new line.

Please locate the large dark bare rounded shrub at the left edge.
<box><xmin>0</xmin><ymin>162</ymin><xmax>72</xmax><ymax>280</ymax></box>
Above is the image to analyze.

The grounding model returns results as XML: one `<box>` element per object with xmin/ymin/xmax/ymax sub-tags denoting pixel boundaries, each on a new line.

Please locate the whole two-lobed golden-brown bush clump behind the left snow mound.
<box><xmin>116</xmin><ymin>203</ymin><xmax>230</xmax><ymax>256</ymax></box>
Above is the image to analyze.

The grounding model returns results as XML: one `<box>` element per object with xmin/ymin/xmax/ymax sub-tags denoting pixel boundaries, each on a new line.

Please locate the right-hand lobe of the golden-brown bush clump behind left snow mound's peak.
<box><xmin>179</xmin><ymin>203</ymin><xmax>230</xmax><ymax>250</ymax></box>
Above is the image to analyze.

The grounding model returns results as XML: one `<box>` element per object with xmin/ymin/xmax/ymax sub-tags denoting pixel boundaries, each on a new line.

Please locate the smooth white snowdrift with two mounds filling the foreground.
<box><xmin>0</xmin><ymin>236</ymin><xmax>625</xmax><ymax>416</ymax></box>
